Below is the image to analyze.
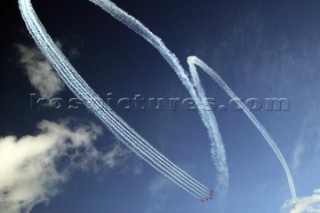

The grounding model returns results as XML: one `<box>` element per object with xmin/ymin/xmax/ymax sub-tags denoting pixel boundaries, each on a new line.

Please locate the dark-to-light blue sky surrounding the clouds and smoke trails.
<box><xmin>0</xmin><ymin>0</ymin><xmax>320</xmax><ymax>213</ymax></box>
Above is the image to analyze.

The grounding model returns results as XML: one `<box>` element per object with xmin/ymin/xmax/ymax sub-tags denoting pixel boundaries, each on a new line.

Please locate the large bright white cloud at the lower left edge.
<box><xmin>0</xmin><ymin>120</ymin><xmax>140</xmax><ymax>213</ymax></box>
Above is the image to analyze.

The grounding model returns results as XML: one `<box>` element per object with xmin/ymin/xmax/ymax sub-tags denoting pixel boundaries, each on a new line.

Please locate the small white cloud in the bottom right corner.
<box><xmin>282</xmin><ymin>189</ymin><xmax>320</xmax><ymax>213</ymax></box>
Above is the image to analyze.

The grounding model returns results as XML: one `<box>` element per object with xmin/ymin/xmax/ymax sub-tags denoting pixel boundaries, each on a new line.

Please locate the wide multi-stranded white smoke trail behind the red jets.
<box><xmin>19</xmin><ymin>0</ymin><xmax>209</xmax><ymax>198</ymax></box>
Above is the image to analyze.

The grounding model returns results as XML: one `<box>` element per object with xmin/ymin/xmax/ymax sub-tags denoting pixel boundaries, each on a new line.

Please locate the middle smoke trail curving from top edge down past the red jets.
<box><xmin>89</xmin><ymin>0</ymin><xmax>229</xmax><ymax>196</ymax></box>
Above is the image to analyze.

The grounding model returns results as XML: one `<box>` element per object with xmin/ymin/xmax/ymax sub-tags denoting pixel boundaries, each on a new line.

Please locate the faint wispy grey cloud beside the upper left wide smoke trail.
<box><xmin>16</xmin><ymin>42</ymin><xmax>64</xmax><ymax>99</ymax></box>
